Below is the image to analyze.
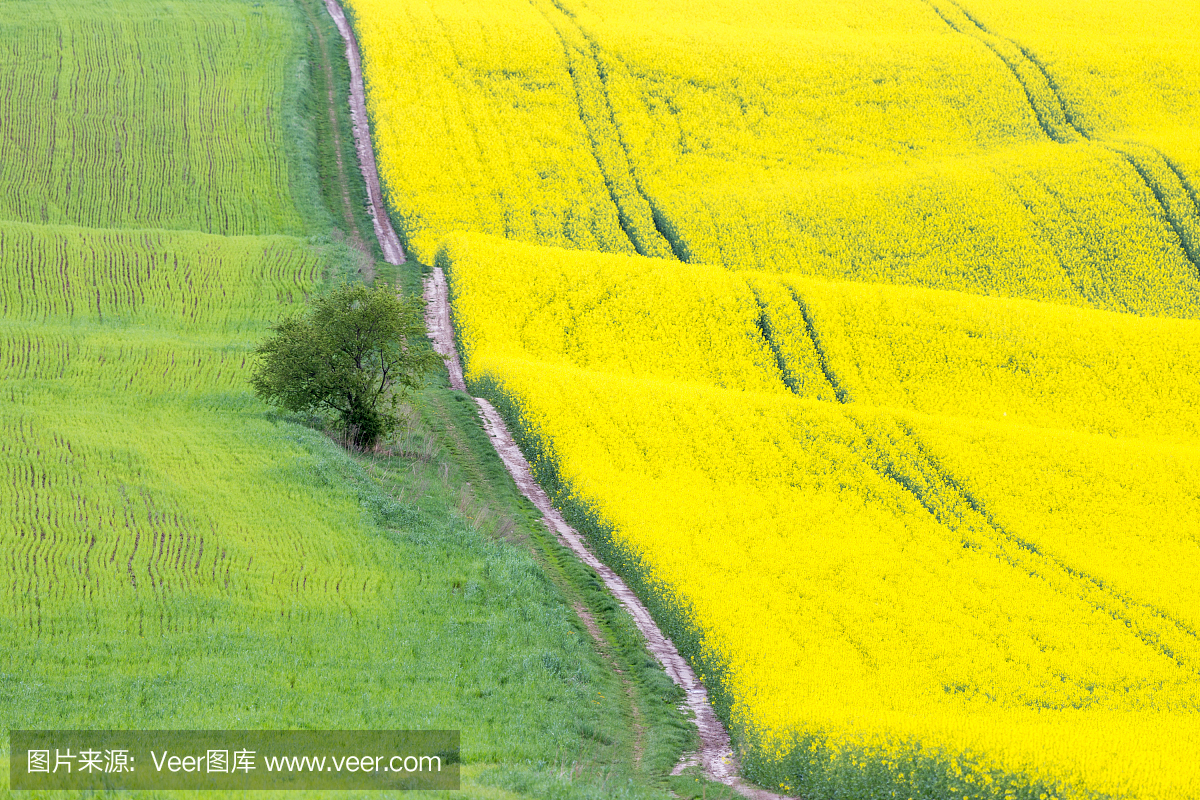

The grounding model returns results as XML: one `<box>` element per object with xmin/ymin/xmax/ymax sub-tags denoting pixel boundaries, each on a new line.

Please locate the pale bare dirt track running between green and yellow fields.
<box><xmin>325</xmin><ymin>0</ymin><xmax>782</xmax><ymax>800</ymax></box>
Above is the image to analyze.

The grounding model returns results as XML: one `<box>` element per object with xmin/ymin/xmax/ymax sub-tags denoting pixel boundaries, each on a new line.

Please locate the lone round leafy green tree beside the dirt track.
<box><xmin>250</xmin><ymin>283</ymin><xmax>438</xmax><ymax>449</ymax></box>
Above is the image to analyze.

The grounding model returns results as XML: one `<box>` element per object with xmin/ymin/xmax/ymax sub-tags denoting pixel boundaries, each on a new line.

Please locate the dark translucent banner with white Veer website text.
<box><xmin>8</xmin><ymin>730</ymin><xmax>458</xmax><ymax>792</ymax></box>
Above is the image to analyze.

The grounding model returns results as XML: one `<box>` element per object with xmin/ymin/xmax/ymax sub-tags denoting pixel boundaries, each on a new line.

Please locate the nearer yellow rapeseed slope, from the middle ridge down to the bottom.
<box><xmin>439</xmin><ymin>236</ymin><xmax>1200</xmax><ymax>800</ymax></box>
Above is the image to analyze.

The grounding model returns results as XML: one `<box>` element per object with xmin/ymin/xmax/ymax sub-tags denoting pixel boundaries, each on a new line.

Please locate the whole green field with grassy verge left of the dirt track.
<box><xmin>0</xmin><ymin>0</ymin><xmax>712</xmax><ymax>798</ymax></box>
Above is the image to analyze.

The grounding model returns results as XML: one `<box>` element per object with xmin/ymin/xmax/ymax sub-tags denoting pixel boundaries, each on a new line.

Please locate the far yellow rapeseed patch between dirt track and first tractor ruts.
<box><xmin>347</xmin><ymin>0</ymin><xmax>634</xmax><ymax>263</ymax></box>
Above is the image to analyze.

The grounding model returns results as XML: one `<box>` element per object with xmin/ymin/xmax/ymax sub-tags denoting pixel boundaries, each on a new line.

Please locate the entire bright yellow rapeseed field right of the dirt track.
<box><xmin>347</xmin><ymin>0</ymin><xmax>1200</xmax><ymax>800</ymax></box>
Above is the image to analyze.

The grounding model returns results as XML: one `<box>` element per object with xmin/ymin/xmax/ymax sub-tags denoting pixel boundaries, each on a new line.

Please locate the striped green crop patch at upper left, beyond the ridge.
<box><xmin>0</xmin><ymin>0</ymin><xmax>314</xmax><ymax>234</ymax></box>
